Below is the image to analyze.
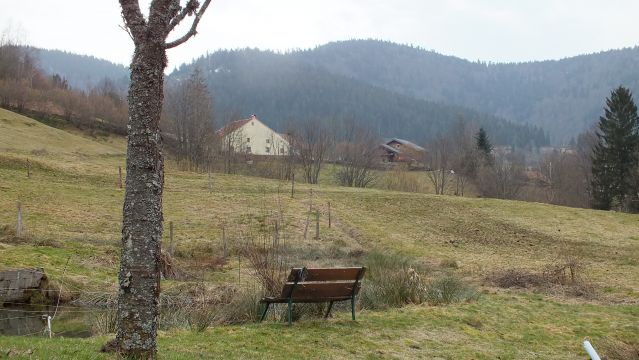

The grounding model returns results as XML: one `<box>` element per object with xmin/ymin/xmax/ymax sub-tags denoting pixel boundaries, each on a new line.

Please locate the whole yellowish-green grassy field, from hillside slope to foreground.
<box><xmin>0</xmin><ymin>109</ymin><xmax>639</xmax><ymax>359</ymax></box>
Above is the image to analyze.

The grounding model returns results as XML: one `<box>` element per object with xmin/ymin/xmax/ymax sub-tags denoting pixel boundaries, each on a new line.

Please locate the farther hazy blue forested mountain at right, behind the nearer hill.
<box><xmin>296</xmin><ymin>40</ymin><xmax>639</xmax><ymax>142</ymax></box>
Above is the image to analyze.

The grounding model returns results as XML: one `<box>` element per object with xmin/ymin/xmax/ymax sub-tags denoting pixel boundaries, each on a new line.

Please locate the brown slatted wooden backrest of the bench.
<box><xmin>281</xmin><ymin>267</ymin><xmax>366</xmax><ymax>300</ymax></box>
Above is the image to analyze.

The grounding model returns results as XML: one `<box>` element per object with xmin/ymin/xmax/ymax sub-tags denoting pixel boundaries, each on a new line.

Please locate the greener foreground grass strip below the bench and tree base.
<box><xmin>0</xmin><ymin>294</ymin><xmax>639</xmax><ymax>359</ymax></box>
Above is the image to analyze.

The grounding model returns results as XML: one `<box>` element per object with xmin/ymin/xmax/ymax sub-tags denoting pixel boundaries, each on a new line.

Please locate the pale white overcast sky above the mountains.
<box><xmin>0</xmin><ymin>0</ymin><xmax>639</xmax><ymax>70</ymax></box>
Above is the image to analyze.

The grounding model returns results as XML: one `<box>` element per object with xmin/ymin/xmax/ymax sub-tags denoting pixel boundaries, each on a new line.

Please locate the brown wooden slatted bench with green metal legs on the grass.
<box><xmin>260</xmin><ymin>267</ymin><xmax>366</xmax><ymax>326</ymax></box>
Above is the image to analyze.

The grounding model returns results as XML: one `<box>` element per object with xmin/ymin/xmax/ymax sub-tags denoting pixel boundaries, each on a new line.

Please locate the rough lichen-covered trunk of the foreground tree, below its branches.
<box><xmin>116</xmin><ymin>37</ymin><xmax>166</xmax><ymax>357</ymax></box>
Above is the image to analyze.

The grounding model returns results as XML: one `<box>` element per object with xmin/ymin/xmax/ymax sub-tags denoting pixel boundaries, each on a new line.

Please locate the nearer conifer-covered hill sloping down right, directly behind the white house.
<box><xmin>169</xmin><ymin>49</ymin><xmax>547</xmax><ymax>146</ymax></box>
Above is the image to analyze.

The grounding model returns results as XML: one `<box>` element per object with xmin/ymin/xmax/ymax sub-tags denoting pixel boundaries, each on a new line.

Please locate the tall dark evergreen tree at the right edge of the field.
<box><xmin>591</xmin><ymin>86</ymin><xmax>639</xmax><ymax>210</ymax></box>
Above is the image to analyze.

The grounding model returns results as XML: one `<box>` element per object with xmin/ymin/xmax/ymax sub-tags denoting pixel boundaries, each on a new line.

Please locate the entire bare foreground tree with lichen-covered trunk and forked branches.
<box><xmin>116</xmin><ymin>0</ymin><xmax>210</xmax><ymax>358</ymax></box>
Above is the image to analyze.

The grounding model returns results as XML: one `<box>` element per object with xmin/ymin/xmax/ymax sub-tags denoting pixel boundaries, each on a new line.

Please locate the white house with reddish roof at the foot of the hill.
<box><xmin>216</xmin><ymin>115</ymin><xmax>289</xmax><ymax>155</ymax></box>
